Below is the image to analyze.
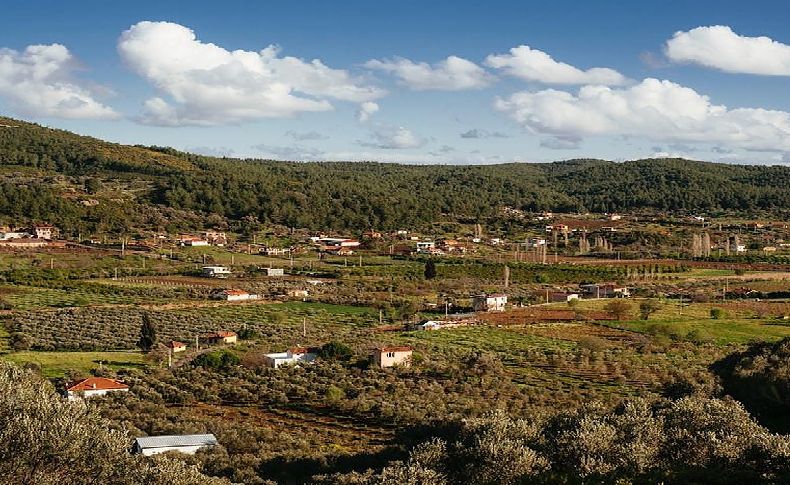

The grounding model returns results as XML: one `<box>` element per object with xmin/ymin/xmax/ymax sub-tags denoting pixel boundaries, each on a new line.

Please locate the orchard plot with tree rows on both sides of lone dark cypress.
<box><xmin>12</xmin><ymin>303</ymin><xmax>384</xmax><ymax>350</ymax></box>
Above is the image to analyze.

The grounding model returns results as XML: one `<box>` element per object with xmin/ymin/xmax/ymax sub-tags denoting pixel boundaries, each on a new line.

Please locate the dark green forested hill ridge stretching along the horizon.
<box><xmin>0</xmin><ymin>117</ymin><xmax>790</xmax><ymax>233</ymax></box>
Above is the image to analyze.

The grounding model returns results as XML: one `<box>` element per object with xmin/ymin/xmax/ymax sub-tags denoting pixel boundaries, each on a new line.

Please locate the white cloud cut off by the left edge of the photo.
<box><xmin>0</xmin><ymin>44</ymin><xmax>118</xmax><ymax>119</ymax></box>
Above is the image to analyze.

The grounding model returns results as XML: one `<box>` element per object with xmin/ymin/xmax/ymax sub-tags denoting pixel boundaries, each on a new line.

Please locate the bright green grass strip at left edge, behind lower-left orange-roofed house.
<box><xmin>0</xmin><ymin>352</ymin><xmax>144</xmax><ymax>378</ymax></box>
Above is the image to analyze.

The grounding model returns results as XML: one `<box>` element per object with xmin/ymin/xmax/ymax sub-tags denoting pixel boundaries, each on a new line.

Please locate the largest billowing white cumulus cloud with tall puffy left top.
<box><xmin>118</xmin><ymin>22</ymin><xmax>385</xmax><ymax>125</ymax></box>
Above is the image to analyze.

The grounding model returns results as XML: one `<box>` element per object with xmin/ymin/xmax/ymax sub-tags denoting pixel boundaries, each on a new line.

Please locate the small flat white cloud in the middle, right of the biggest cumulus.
<box><xmin>365</xmin><ymin>56</ymin><xmax>493</xmax><ymax>91</ymax></box>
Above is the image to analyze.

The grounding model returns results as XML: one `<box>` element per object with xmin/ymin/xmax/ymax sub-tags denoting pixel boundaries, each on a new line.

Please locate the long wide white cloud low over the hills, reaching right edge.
<box><xmin>495</xmin><ymin>78</ymin><xmax>790</xmax><ymax>150</ymax></box>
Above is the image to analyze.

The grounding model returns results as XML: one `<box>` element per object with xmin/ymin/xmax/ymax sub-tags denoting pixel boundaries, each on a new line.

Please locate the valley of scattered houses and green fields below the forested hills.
<box><xmin>0</xmin><ymin>209</ymin><xmax>790</xmax><ymax>478</ymax></box>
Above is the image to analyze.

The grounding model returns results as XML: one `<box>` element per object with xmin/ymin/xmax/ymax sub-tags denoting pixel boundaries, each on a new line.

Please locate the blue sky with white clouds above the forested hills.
<box><xmin>0</xmin><ymin>0</ymin><xmax>790</xmax><ymax>164</ymax></box>
